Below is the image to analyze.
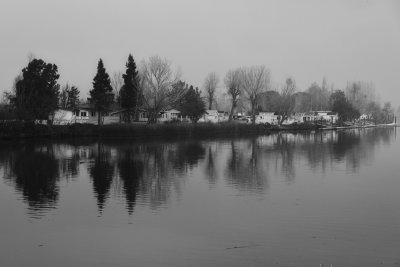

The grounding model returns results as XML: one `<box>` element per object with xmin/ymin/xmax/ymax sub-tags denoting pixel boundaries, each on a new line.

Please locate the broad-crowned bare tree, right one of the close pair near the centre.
<box><xmin>241</xmin><ymin>66</ymin><xmax>270</xmax><ymax>124</ymax></box>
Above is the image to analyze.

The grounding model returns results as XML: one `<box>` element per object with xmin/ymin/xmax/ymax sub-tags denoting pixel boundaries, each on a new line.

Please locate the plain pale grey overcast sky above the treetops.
<box><xmin>0</xmin><ymin>0</ymin><xmax>400</xmax><ymax>106</ymax></box>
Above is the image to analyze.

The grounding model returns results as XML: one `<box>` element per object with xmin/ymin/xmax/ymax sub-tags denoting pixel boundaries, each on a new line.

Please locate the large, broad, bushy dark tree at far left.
<box><xmin>9</xmin><ymin>59</ymin><xmax>60</xmax><ymax>121</ymax></box>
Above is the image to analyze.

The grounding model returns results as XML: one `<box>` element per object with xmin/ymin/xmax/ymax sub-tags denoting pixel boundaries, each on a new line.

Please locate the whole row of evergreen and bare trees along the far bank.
<box><xmin>0</xmin><ymin>55</ymin><xmax>400</xmax><ymax>125</ymax></box>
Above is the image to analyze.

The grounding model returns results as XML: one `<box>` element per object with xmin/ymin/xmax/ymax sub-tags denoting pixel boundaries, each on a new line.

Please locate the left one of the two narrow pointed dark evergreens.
<box><xmin>88</xmin><ymin>59</ymin><xmax>114</xmax><ymax>125</ymax></box>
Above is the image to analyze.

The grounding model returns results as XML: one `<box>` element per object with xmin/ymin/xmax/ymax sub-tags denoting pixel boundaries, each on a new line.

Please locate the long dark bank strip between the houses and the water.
<box><xmin>0</xmin><ymin>122</ymin><xmax>399</xmax><ymax>140</ymax></box>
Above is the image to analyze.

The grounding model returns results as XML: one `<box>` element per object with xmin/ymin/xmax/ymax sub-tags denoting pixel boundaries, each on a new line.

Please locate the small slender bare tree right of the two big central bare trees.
<box><xmin>279</xmin><ymin>77</ymin><xmax>296</xmax><ymax>124</ymax></box>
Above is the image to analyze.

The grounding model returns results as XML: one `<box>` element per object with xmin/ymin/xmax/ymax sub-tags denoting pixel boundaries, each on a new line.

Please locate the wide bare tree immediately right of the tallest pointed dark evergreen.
<box><xmin>141</xmin><ymin>56</ymin><xmax>185</xmax><ymax>123</ymax></box>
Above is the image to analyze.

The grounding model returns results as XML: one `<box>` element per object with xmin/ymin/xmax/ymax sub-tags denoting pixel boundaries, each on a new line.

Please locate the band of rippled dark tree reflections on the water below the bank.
<box><xmin>0</xmin><ymin>128</ymin><xmax>394</xmax><ymax>218</ymax></box>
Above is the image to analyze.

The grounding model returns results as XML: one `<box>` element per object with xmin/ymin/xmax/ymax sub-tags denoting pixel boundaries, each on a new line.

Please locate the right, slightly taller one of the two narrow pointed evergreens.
<box><xmin>120</xmin><ymin>54</ymin><xmax>140</xmax><ymax>122</ymax></box>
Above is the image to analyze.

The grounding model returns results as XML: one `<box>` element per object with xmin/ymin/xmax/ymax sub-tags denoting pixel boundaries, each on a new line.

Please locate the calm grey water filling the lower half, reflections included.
<box><xmin>0</xmin><ymin>128</ymin><xmax>400</xmax><ymax>266</ymax></box>
